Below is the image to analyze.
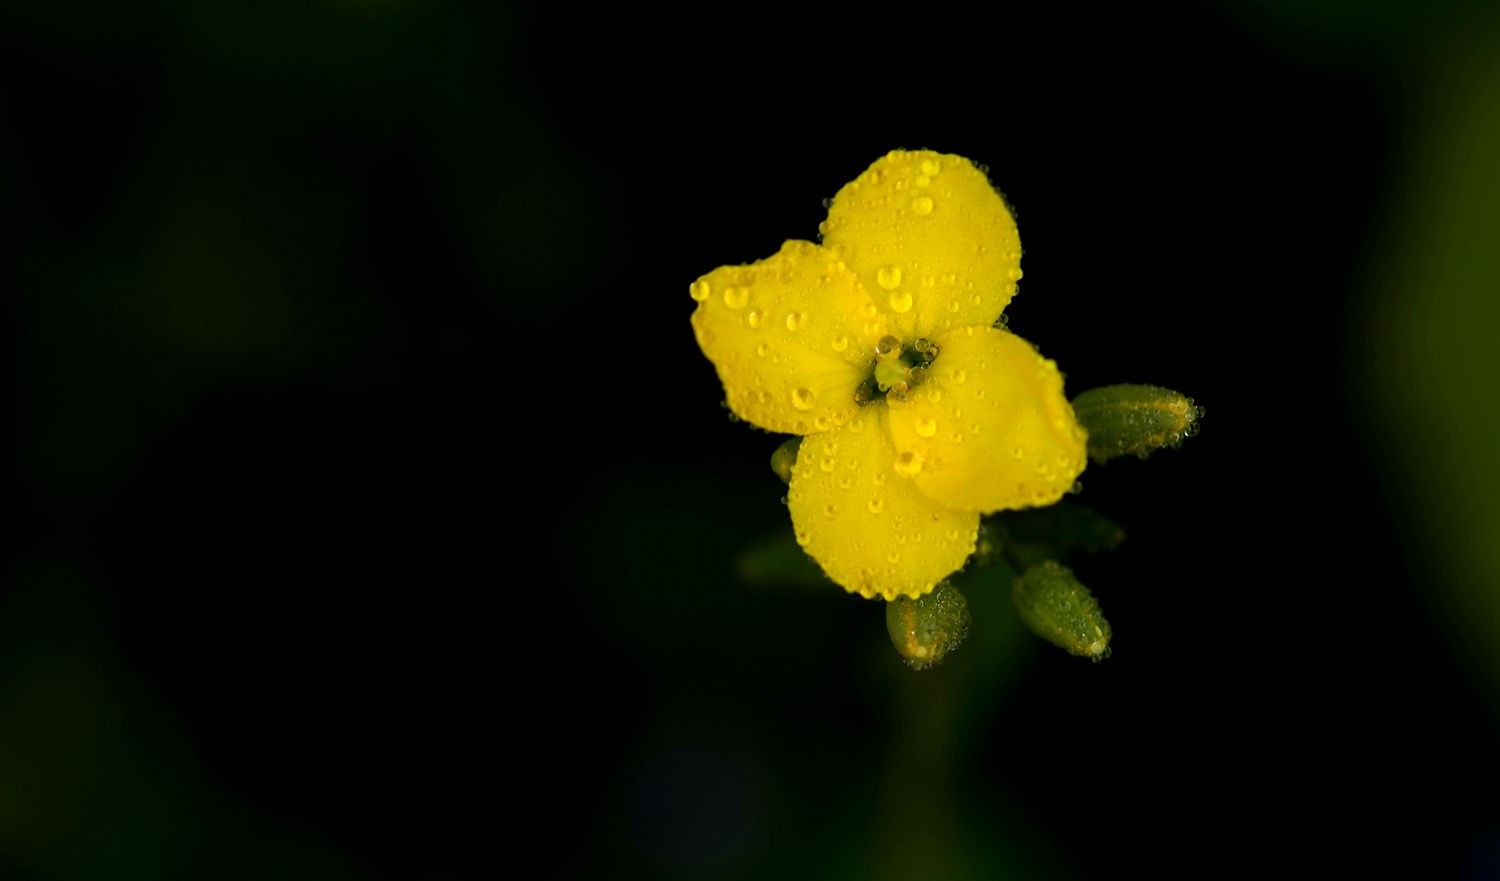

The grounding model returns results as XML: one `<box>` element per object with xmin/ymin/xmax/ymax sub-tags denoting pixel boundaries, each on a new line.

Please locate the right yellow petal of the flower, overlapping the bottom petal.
<box><xmin>888</xmin><ymin>327</ymin><xmax>1088</xmax><ymax>512</ymax></box>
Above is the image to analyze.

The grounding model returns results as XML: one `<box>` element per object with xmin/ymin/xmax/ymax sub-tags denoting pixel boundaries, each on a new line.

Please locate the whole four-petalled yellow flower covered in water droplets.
<box><xmin>690</xmin><ymin>150</ymin><xmax>1088</xmax><ymax>600</ymax></box>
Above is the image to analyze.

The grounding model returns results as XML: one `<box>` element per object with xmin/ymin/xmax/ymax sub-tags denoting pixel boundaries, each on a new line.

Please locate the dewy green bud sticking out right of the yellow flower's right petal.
<box><xmin>1073</xmin><ymin>386</ymin><xmax>1203</xmax><ymax>464</ymax></box>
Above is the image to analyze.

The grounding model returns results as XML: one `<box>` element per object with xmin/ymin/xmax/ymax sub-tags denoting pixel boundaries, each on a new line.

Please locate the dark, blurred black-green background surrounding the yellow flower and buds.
<box><xmin>0</xmin><ymin>0</ymin><xmax>1500</xmax><ymax>881</ymax></box>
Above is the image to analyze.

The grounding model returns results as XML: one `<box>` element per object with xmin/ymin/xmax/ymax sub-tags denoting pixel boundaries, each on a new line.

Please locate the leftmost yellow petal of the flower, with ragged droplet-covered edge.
<box><xmin>690</xmin><ymin>242</ymin><xmax>887</xmax><ymax>434</ymax></box>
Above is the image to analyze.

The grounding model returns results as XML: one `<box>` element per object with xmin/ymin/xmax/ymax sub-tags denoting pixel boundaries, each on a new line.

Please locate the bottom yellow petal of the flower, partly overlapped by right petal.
<box><xmin>786</xmin><ymin>404</ymin><xmax>980</xmax><ymax>600</ymax></box>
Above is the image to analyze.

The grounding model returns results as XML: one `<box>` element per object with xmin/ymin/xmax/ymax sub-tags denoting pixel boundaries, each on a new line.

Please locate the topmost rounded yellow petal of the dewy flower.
<box><xmin>822</xmin><ymin>150</ymin><xmax>1022</xmax><ymax>341</ymax></box>
